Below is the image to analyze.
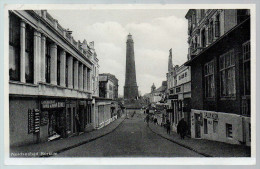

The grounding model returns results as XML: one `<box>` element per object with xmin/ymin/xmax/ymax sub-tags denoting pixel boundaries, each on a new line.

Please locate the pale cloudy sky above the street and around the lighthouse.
<box><xmin>48</xmin><ymin>9</ymin><xmax>188</xmax><ymax>96</ymax></box>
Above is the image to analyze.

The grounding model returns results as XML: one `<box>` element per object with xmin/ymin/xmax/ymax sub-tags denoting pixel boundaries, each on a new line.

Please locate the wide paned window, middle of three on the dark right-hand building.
<box><xmin>219</xmin><ymin>50</ymin><xmax>236</xmax><ymax>97</ymax></box>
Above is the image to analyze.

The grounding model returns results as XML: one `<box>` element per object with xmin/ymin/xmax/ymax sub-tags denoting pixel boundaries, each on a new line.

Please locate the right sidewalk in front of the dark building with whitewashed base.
<box><xmin>149</xmin><ymin>123</ymin><xmax>251</xmax><ymax>157</ymax></box>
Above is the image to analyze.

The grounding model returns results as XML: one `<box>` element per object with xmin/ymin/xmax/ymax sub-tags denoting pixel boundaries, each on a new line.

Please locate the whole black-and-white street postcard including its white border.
<box><xmin>4</xmin><ymin>4</ymin><xmax>256</xmax><ymax>165</ymax></box>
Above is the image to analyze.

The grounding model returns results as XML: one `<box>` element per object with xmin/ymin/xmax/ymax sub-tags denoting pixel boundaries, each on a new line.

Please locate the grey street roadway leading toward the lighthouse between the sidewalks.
<box><xmin>56</xmin><ymin>114</ymin><xmax>204</xmax><ymax>157</ymax></box>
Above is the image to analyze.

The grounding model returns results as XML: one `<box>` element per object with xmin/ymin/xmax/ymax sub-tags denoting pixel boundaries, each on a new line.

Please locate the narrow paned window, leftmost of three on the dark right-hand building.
<box><xmin>204</xmin><ymin>60</ymin><xmax>215</xmax><ymax>98</ymax></box>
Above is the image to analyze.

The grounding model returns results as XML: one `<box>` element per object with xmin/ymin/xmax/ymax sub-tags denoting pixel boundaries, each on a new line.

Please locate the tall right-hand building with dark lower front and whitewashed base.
<box><xmin>185</xmin><ymin>9</ymin><xmax>251</xmax><ymax>145</ymax></box>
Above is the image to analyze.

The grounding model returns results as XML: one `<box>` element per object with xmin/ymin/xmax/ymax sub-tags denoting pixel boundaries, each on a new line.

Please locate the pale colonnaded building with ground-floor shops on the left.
<box><xmin>9</xmin><ymin>10</ymin><xmax>97</xmax><ymax>146</ymax></box>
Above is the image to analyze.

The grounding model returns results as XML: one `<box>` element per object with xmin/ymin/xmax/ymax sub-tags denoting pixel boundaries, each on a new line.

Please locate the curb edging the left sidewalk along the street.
<box><xmin>39</xmin><ymin>117</ymin><xmax>126</xmax><ymax>157</ymax></box>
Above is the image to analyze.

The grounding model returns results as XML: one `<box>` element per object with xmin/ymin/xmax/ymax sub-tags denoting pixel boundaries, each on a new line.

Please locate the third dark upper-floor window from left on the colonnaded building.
<box><xmin>45</xmin><ymin>40</ymin><xmax>51</xmax><ymax>83</ymax></box>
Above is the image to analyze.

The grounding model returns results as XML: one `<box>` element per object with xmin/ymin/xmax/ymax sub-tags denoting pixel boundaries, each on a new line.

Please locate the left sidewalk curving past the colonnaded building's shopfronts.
<box><xmin>10</xmin><ymin>115</ymin><xmax>125</xmax><ymax>157</ymax></box>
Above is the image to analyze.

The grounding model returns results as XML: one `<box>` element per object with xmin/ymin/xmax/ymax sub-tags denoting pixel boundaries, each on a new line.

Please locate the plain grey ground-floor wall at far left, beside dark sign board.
<box><xmin>9</xmin><ymin>97</ymin><xmax>38</xmax><ymax>146</ymax></box>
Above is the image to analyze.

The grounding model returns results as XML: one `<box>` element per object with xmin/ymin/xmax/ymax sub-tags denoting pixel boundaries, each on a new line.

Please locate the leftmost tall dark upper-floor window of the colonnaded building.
<box><xmin>9</xmin><ymin>13</ymin><xmax>20</xmax><ymax>81</ymax></box>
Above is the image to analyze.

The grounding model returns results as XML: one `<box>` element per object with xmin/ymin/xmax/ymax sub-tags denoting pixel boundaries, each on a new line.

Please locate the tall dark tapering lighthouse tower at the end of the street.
<box><xmin>124</xmin><ymin>33</ymin><xmax>138</xmax><ymax>99</ymax></box>
